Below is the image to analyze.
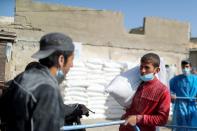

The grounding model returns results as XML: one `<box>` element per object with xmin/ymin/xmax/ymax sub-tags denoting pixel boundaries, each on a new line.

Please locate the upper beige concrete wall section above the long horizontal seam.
<box><xmin>15</xmin><ymin>0</ymin><xmax>190</xmax><ymax>53</ymax></box>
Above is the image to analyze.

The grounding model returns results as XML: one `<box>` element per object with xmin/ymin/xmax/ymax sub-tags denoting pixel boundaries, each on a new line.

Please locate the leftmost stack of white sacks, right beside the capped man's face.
<box><xmin>62</xmin><ymin>61</ymin><xmax>88</xmax><ymax>105</ymax></box>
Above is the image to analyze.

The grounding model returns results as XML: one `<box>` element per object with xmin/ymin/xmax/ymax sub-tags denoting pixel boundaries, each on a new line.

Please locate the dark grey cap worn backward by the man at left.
<box><xmin>32</xmin><ymin>32</ymin><xmax>75</xmax><ymax>59</ymax></box>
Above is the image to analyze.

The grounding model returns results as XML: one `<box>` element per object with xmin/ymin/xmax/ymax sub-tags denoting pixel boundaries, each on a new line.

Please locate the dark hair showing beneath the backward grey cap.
<box><xmin>39</xmin><ymin>50</ymin><xmax>73</xmax><ymax>68</ymax></box>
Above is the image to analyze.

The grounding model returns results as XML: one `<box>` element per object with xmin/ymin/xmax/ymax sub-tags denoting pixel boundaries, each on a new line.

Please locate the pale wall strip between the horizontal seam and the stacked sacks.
<box><xmin>81</xmin><ymin>45</ymin><xmax>187</xmax><ymax>73</ymax></box>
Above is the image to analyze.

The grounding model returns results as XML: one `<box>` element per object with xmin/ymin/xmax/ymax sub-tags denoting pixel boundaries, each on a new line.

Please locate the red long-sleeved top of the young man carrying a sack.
<box><xmin>119</xmin><ymin>78</ymin><xmax>170</xmax><ymax>131</ymax></box>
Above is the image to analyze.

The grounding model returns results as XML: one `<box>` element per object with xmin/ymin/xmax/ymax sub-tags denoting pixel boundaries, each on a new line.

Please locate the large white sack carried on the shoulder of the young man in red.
<box><xmin>106</xmin><ymin>66</ymin><xmax>142</xmax><ymax>108</ymax></box>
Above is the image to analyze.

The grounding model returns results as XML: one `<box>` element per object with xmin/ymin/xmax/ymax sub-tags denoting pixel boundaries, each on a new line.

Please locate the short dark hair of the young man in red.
<box><xmin>140</xmin><ymin>53</ymin><xmax>160</xmax><ymax>67</ymax></box>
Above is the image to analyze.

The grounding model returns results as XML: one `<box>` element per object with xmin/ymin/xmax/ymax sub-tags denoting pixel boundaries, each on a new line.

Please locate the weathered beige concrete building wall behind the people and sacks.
<box><xmin>0</xmin><ymin>0</ymin><xmax>190</xmax><ymax>80</ymax></box>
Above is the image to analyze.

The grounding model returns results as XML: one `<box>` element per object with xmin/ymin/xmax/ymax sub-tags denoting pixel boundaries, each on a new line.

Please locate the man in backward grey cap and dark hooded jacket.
<box><xmin>0</xmin><ymin>33</ymin><xmax>88</xmax><ymax>131</ymax></box>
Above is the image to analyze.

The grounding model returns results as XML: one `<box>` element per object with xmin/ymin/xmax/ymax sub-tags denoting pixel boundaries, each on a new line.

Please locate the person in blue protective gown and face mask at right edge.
<box><xmin>170</xmin><ymin>60</ymin><xmax>197</xmax><ymax>131</ymax></box>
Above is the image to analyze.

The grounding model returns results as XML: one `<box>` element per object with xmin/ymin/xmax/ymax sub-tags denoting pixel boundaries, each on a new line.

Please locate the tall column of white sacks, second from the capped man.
<box><xmin>85</xmin><ymin>59</ymin><xmax>107</xmax><ymax>119</ymax></box>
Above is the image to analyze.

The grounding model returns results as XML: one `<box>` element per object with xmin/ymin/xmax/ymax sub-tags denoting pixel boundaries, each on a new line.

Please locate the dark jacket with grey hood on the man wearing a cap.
<box><xmin>0</xmin><ymin>63</ymin><xmax>78</xmax><ymax>131</ymax></box>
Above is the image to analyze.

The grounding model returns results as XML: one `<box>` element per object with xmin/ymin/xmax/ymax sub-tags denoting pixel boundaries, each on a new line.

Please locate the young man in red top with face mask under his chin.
<box><xmin>119</xmin><ymin>53</ymin><xmax>170</xmax><ymax>131</ymax></box>
